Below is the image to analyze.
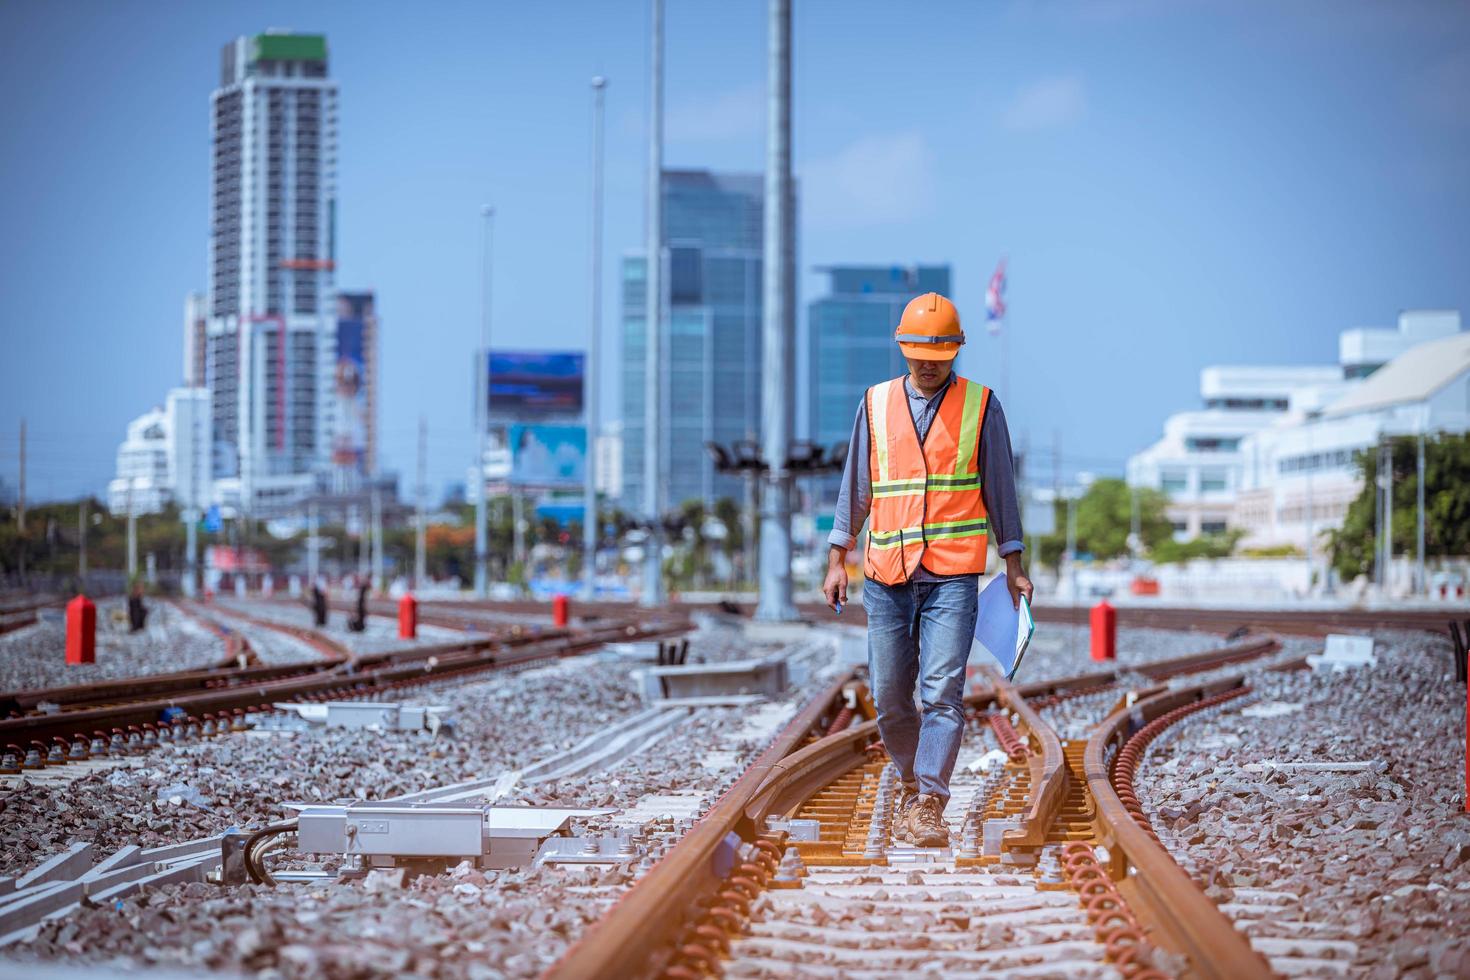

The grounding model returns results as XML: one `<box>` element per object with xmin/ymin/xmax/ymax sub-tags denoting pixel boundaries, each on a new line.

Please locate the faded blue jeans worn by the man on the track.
<box><xmin>863</xmin><ymin>576</ymin><xmax>979</xmax><ymax>802</ymax></box>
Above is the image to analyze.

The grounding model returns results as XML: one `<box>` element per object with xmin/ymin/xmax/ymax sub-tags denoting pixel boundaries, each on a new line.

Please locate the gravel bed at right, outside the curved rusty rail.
<box><xmin>1136</xmin><ymin>633</ymin><xmax>1470</xmax><ymax>977</ymax></box>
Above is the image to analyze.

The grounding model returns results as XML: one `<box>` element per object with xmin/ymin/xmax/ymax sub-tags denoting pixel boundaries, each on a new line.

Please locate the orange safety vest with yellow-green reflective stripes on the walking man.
<box><xmin>863</xmin><ymin>375</ymin><xmax>991</xmax><ymax>585</ymax></box>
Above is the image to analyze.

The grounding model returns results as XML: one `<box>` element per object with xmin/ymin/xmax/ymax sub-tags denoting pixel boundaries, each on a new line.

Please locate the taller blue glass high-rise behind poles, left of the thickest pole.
<box><xmin>622</xmin><ymin>170</ymin><xmax>764</xmax><ymax>511</ymax></box>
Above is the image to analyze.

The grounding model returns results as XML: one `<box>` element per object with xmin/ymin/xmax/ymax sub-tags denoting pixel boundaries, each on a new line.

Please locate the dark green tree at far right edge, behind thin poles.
<box><xmin>1327</xmin><ymin>433</ymin><xmax>1470</xmax><ymax>580</ymax></box>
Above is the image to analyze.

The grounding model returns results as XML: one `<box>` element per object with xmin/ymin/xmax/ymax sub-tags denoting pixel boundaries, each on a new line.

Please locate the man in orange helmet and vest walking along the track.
<box><xmin>822</xmin><ymin>292</ymin><xmax>1032</xmax><ymax>848</ymax></box>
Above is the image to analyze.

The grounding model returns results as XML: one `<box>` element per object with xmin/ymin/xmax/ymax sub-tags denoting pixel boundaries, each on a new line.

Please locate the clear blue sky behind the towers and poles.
<box><xmin>0</xmin><ymin>0</ymin><xmax>1470</xmax><ymax>498</ymax></box>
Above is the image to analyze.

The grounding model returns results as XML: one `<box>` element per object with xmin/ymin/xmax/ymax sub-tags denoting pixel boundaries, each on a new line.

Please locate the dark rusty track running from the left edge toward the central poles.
<box><xmin>0</xmin><ymin>610</ymin><xmax>688</xmax><ymax>773</ymax></box>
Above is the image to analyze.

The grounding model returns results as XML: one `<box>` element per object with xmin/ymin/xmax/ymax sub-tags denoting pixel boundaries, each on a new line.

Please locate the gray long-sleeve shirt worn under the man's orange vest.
<box><xmin>828</xmin><ymin>372</ymin><xmax>1025</xmax><ymax>582</ymax></box>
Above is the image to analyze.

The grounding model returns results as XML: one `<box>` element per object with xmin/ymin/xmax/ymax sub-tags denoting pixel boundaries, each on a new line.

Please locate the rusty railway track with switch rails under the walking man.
<box><xmin>547</xmin><ymin>638</ymin><xmax>1301</xmax><ymax>979</ymax></box>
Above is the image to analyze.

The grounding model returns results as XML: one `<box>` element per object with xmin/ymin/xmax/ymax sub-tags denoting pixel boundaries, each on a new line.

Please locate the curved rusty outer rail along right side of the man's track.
<box><xmin>1083</xmin><ymin>676</ymin><xmax>1273</xmax><ymax>980</ymax></box>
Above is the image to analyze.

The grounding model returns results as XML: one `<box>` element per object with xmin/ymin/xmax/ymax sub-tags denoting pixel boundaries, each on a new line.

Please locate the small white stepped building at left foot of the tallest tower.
<box><xmin>107</xmin><ymin>388</ymin><xmax>210</xmax><ymax>514</ymax></box>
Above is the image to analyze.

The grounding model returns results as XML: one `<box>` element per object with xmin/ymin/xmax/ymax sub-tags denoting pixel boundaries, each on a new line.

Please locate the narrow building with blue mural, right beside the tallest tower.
<box><xmin>332</xmin><ymin>291</ymin><xmax>378</xmax><ymax>481</ymax></box>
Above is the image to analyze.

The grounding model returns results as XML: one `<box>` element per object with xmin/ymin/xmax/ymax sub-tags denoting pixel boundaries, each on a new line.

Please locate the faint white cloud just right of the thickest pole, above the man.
<box><xmin>798</xmin><ymin>131</ymin><xmax>933</xmax><ymax>228</ymax></box>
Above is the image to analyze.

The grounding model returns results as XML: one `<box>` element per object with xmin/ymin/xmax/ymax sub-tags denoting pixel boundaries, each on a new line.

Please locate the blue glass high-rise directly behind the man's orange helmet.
<box><xmin>807</xmin><ymin>266</ymin><xmax>950</xmax><ymax>504</ymax></box>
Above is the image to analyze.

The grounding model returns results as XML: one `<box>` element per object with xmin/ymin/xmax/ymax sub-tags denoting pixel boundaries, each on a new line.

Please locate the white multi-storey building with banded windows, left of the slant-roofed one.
<box><xmin>1127</xmin><ymin>310</ymin><xmax>1460</xmax><ymax>550</ymax></box>
